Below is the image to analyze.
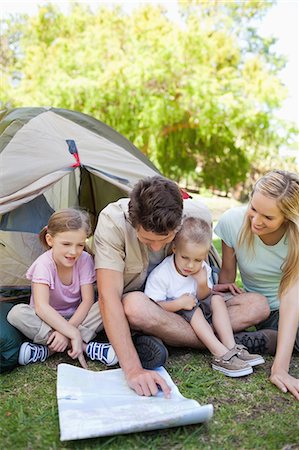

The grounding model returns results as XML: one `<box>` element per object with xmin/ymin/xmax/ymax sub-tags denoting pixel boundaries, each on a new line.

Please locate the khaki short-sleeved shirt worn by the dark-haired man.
<box><xmin>94</xmin><ymin>198</ymin><xmax>212</xmax><ymax>293</ymax></box>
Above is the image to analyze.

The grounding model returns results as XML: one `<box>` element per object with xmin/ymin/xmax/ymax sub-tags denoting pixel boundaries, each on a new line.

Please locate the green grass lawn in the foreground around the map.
<box><xmin>0</xmin><ymin>195</ymin><xmax>299</xmax><ymax>450</ymax></box>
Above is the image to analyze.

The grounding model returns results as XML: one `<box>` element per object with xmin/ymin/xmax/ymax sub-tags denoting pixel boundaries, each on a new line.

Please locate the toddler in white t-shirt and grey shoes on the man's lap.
<box><xmin>144</xmin><ymin>217</ymin><xmax>264</xmax><ymax>377</ymax></box>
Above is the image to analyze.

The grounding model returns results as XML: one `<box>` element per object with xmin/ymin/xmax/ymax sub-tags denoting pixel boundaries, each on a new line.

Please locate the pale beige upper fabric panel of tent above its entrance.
<box><xmin>0</xmin><ymin>108</ymin><xmax>158</xmax><ymax>214</ymax></box>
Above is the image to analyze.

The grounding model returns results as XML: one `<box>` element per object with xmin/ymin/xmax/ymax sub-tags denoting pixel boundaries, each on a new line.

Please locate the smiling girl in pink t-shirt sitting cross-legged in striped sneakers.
<box><xmin>7</xmin><ymin>208</ymin><xmax>118</xmax><ymax>368</ymax></box>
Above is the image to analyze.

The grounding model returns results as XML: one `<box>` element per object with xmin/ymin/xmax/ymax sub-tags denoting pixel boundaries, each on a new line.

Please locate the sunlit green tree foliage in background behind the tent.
<box><xmin>0</xmin><ymin>0</ymin><xmax>296</xmax><ymax>193</ymax></box>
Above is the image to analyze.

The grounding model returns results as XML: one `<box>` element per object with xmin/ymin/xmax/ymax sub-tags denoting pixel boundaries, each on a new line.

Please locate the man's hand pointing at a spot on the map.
<box><xmin>126</xmin><ymin>368</ymin><xmax>171</xmax><ymax>398</ymax></box>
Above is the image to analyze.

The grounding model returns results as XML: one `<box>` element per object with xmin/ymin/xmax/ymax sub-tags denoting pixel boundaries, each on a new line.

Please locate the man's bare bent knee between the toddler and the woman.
<box><xmin>226</xmin><ymin>292</ymin><xmax>270</xmax><ymax>332</ymax></box>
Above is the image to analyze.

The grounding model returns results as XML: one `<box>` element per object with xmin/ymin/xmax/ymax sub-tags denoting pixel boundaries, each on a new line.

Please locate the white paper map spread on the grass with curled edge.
<box><xmin>57</xmin><ymin>364</ymin><xmax>213</xmax><ymax>441</ymax></box>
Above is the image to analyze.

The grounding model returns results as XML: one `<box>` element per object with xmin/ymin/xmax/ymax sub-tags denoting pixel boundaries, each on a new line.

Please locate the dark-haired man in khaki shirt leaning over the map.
<box><xmin>94</xmin><ymin>176</ymin><xmax>270</xmax><ymax>396</ymax></box>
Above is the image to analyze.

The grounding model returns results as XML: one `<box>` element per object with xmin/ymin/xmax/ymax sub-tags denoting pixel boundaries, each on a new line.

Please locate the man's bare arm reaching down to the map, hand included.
<box><xmin>96</xmin><ymin>269</ymin><xmax>170</xmax><ymax>397</ymax></box>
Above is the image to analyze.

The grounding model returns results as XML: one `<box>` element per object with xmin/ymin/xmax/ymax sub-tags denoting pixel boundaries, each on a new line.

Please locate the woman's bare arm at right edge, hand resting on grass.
<box><xmin>270</xmin><ymin>279</ymin><xmax>299</xmax><ymax>400</ymax></box>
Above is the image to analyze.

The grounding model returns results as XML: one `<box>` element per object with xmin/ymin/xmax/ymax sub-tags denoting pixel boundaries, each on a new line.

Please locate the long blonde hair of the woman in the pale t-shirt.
<box><xmin>238</xmin><ymin>170</ymin><xmax>299</xmax><ymax>297</ymax></box>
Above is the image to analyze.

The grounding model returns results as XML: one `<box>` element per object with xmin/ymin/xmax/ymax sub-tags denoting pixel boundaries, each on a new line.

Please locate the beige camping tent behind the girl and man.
<box><xmin>0</xmin><ymin>107</ymin><xmax>159</xmax><ymax>298</ymax></box>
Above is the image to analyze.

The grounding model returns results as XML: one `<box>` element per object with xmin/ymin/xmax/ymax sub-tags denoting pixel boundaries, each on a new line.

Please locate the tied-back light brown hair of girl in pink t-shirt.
<box><xmin>39</xmin><ymin>208</ymin><xmax>92</xmax><ymax>251</ymax></box>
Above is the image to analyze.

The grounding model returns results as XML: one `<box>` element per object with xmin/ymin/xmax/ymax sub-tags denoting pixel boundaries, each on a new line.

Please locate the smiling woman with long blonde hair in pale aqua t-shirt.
<box><xmin>215</xmin><ymin>170</ymin><xmax>299</xmax><ymax>400</ymax></box>
